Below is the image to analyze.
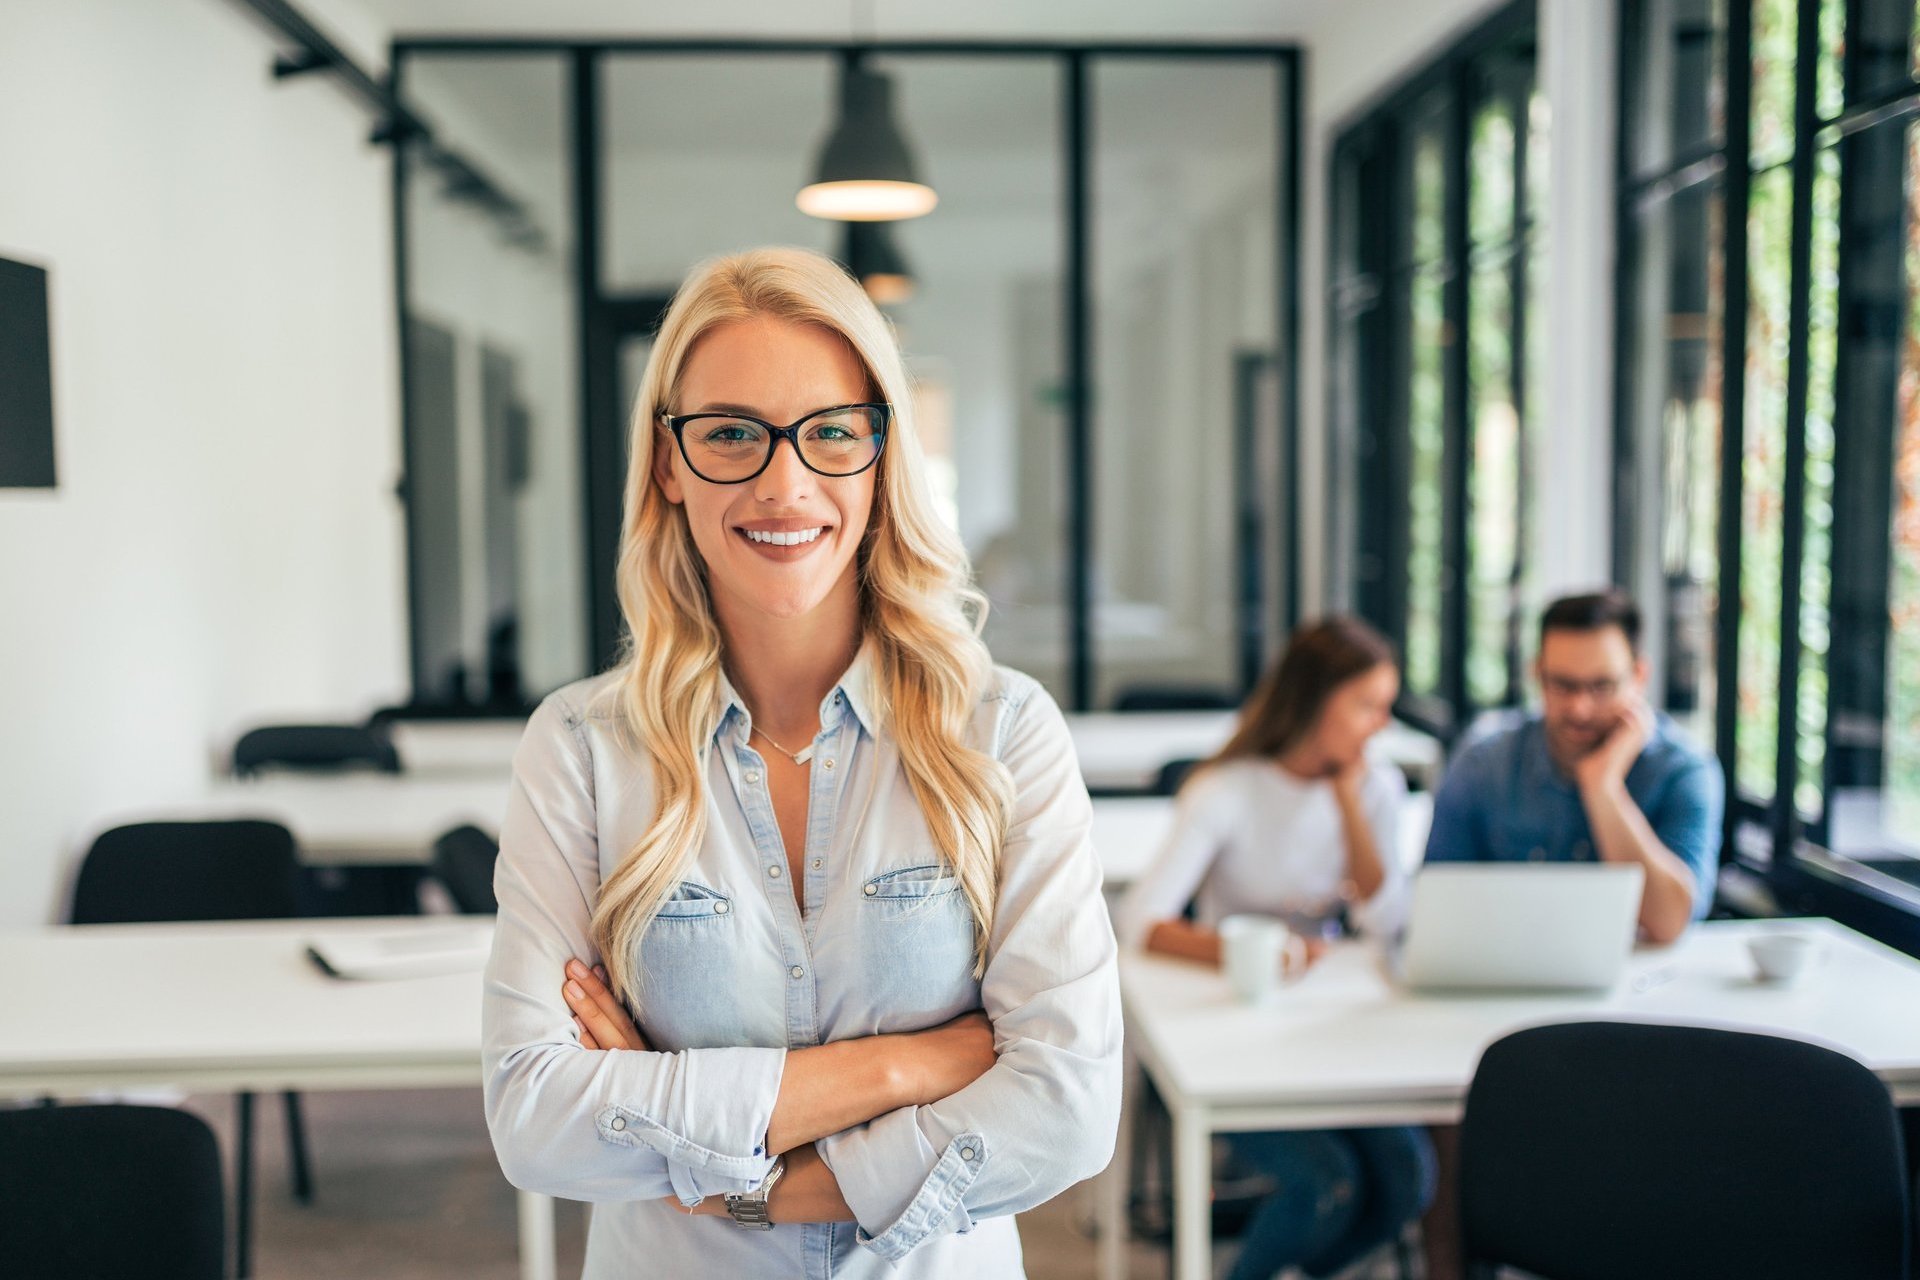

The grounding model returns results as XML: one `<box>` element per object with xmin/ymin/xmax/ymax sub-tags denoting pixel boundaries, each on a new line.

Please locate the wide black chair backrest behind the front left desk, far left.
<box><xmin>69</xmin><ymin>819</ymin><xmax>296</xmax><ymax>925</ymax></box>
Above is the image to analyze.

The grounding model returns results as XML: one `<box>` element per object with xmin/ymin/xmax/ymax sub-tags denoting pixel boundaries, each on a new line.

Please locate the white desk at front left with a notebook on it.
<box><xmin>0</xmin><ymin>917</ymin><xmax>555</xmax><ymax>1280</ymax></box>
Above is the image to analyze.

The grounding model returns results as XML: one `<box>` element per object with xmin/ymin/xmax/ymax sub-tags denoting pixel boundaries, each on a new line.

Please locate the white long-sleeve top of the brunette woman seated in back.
<box><xmin>1116</xmin><ymin>758</ymin><xmax>1407</xmax><ymax>946</ymax></box>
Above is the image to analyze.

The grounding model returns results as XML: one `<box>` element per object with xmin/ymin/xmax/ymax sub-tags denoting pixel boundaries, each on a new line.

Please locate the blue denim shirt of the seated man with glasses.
<box><xmin>1427</xmin><ymin>712</ymin><xmax>1726</xmax><ymax>919</ymax></box>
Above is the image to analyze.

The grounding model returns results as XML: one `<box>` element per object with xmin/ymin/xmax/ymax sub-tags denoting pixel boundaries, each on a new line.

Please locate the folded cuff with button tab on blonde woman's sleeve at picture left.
<box><xmin>593</xmin><ymin>1048</ymin><xmax>787</xmax><ymax>1209</ymax></box>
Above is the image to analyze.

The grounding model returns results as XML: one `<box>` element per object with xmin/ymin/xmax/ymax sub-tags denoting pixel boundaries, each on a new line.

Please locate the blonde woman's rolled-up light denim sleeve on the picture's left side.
<box><xmin>480</xmin><ymin>695</ymin><xmax>787</xmax><ymax>1205</ymax></box>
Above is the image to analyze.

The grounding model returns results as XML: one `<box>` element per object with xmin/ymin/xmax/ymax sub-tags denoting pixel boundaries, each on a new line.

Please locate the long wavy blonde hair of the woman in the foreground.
<box><xmin>593</xmin><ymin>248</ymin><xmax>1012</xmax><ymax>1006</ymax></box>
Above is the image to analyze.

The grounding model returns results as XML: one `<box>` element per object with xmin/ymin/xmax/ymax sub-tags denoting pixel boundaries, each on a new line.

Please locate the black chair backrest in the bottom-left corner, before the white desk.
<box><xmin>0</xmin><ymin>1105</ymin><xmax>227</xmax><ymax>1280</ymax></box>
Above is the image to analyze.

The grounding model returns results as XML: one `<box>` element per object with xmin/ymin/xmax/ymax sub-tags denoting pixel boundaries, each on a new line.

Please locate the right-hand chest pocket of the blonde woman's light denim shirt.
<box><xmin>854</xmin><ymin>864</ymin><xmax>979</xmax><ymax>1031</ymax></box>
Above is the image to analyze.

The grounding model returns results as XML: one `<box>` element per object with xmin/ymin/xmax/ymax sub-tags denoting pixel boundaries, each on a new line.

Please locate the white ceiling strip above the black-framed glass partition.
<box><xmin>361</xmin><ymin>0</ymin><xmax>1352</xmax><ymax>40</ymax></box>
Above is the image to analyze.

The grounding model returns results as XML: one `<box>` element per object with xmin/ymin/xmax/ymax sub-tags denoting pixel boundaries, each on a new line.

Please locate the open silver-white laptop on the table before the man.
<box><xmin>1394</xmin><ymin>862</ymin><xmax>1645</xmax><ymax>990</ymax></box>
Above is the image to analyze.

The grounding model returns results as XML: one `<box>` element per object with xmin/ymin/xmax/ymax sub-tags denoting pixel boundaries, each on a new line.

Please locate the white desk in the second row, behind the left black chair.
<box><xmin>131</xmin><ymin>770</ymin><xmax>513</xmax><ymax>865</ymax></box>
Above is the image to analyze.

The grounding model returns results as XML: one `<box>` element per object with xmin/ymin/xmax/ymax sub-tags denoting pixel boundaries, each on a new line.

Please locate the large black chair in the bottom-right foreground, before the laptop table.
<box><xmin>1459</xmin><ymin>1023</ymin><xmax>1908</xmax><ymax>1280</ymax></box>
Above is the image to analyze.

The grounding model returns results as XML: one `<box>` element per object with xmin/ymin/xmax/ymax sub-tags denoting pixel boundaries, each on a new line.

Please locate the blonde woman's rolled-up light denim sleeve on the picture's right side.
<box><xmin>816</xmin><ymin>687</ymin><xmax>1121</xmax><ymax>1259</ymax></box>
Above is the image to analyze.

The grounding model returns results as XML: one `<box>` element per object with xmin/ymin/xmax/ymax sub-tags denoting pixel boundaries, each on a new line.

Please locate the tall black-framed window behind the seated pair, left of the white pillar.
<box><xmin>1331</xmin><ymin>6</ymin><xmax>1548</xmax><ymax>731</ymax></box>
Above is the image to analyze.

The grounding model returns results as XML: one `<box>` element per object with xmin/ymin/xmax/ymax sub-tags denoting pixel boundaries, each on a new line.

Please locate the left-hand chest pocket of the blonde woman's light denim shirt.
<box><xmin>639</xmin><ymin>881</ymin><xmax>749</xmax><ymax>1050</ymax></box>
